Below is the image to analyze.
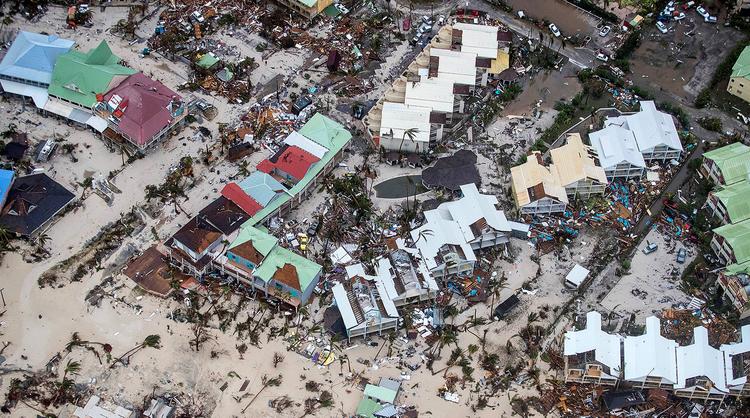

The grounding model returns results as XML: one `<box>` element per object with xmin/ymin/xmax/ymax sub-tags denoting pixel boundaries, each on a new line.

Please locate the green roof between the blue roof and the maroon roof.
<box><xmin>49</xmin><ymin>41</ymin><xmax>137</xmax><ymax>108</ymax></box>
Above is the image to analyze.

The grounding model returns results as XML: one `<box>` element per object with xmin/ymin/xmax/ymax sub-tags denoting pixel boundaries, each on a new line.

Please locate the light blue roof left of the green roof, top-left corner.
<box><xmin>0</xmin><ymin>31</ymin><xmax>75</xmax><ymax>84</ymax></box>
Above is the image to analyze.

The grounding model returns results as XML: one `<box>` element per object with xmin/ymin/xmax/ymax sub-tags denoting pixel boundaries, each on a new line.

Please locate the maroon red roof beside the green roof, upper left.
<box><xmin>103</xmin><ymin>73</ymin><xmax>182</xmax><ymax>146</ymax></box>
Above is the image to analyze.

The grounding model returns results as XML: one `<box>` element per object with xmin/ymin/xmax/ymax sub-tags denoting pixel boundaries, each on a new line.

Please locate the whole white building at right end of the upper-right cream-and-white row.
<box><xmin>604</xmin><ymin>101</ymin><xmax>682</xmax><ymax>162</ymax></box>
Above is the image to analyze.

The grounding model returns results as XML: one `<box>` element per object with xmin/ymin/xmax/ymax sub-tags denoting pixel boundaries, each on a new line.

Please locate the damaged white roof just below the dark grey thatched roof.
<box><xmin>411</xmin><ymin>184</ymin><xmax>511</xmax><ymax>269</ymax></box>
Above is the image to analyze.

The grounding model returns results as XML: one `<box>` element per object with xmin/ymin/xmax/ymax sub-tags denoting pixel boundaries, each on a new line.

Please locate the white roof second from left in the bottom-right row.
<box><xmin>625</xmin><ymin>316</ymin><xmax>677</xmax><ymax>383</ymax></box>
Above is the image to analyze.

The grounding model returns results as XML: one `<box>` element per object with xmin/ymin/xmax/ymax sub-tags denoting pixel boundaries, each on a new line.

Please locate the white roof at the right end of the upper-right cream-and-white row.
<box><xmin>604</xmin><ymin>101</ymin><xmax>682</xmax><ymax>152</ymax></box>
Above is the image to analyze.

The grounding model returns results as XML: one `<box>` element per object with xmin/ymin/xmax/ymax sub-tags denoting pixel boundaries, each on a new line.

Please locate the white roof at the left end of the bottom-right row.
<box><xmin>564</xmin><ymin>311</ymin><xmax>622</xmax><ymax>376</ymax></box>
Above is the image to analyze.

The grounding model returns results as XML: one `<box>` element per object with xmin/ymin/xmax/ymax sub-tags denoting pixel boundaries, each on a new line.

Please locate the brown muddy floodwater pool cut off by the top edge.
<box><xmin>505</xmin><ymin>0</ymin><xmax>597</xmax><ymax>36</ymax></box>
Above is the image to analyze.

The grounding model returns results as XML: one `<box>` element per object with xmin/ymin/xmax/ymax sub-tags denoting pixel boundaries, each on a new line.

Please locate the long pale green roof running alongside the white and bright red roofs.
<box><xmin>245</xmin><ymin>113</ymin><xmax>352</xmax><ymax>226</ymax></box>
